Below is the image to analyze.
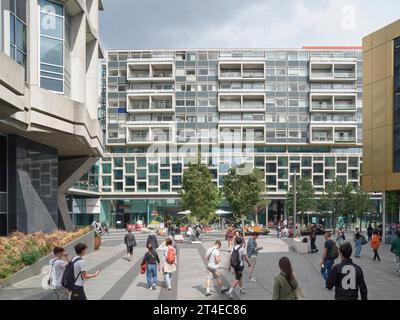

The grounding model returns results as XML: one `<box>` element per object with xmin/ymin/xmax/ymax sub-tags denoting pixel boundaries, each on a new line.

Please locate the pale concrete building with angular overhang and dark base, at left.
<box><xmin>0</xmin><ymin>0</ymin><xmax>103</xmax><ymax>235</ymax></box>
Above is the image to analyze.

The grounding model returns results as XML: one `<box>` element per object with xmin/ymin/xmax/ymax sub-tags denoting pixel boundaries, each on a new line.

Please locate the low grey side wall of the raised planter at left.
<box><xmin>0</xmin><ymin>231</ymin><xmax>94</xmax><ymax>288</ymax></box>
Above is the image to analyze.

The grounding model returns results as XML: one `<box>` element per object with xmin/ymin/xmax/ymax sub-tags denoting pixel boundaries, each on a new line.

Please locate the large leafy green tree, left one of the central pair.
<box><xmin>180</xmin><ymin>162</ymin><xmax>221</xmax><ymax>222</ymax></box>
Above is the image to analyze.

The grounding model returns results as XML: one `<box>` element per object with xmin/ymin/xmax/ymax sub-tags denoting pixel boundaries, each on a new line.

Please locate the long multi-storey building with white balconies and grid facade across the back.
<box><xmin>70</xmin><ymin>47</ymin><xmax>379</xmax><ymax>228</ymax></box>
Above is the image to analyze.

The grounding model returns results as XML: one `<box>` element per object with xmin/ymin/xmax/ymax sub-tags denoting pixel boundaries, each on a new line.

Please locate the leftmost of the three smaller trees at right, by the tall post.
<box><xmin>286</xmin><ymin>178</ymin><xmax>317</xmax><ymax>225</ymax></box>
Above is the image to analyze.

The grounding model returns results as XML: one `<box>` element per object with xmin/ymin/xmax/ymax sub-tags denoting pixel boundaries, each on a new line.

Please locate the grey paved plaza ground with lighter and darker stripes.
<box><xmin>0</xmin><ymin>231</ymin><xmax>400</xmax><ymax>300</ymax></box>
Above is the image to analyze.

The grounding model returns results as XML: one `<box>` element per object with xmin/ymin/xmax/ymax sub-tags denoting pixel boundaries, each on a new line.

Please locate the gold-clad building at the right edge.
<box><xmin>363</xmin><ymin>20</ymin><xmax>400</xmax><ymax>240</ymax></box>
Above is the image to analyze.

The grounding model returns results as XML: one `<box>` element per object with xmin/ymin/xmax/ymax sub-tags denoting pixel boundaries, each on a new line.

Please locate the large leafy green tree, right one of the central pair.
<box><xmin>222</xmin><ymin>166</ymin><xmax>265</xmax><ymax>228</ymax></box>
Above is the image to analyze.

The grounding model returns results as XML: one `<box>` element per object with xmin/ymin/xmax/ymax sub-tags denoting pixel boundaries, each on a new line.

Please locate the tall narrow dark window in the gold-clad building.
<box><xmin>394</xmin><ymin>38</ymin><xmax>400</xmax><ymax>172</ymax></box>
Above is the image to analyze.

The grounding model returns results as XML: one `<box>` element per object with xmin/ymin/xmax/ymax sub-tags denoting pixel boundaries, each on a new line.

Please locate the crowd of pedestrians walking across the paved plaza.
<box><xmin>48</xmin><ymin>222</ymin><xmax>400</xmax><ymax>300</ymax></box>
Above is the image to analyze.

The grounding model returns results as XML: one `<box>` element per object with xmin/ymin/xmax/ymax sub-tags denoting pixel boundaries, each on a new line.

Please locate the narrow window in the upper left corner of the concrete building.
<box><xmin>10</xmin><ymin>0</ymin><xmax>27</xmax><ymax>79</ymax></box>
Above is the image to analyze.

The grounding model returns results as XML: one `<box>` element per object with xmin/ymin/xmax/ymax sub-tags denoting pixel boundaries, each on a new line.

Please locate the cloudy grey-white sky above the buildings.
<box><xmin>100</xmin><ymin>0</ymin><xmax>400</xmax><ymax>50</ymax></box>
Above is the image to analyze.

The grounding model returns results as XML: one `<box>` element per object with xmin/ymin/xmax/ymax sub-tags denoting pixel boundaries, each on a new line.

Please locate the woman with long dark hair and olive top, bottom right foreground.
<box><xmin>272</xmin><ymin>257</ymin><xmax>299</xmax><ymax>300</ymax></box>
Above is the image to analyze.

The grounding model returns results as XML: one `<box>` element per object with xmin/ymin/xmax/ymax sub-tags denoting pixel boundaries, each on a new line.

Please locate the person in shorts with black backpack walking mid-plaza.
<box><xmin>224</xmin><ymin>237</ymin><xmax>251</xmax><ymax>299</ymax></box>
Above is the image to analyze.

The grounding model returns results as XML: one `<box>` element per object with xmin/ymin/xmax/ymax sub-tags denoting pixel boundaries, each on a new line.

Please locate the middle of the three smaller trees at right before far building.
<box><xmin>319</xmin><ymin>179</ymin><xmax>351</xmax><ymax>230</ymax></box>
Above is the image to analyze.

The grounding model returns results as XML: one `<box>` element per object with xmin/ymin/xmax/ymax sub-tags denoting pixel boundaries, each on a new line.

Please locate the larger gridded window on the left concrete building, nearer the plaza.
<box><xmin>39</xmin><ymin>0</ymin><xmax>71</xmax><ymax>96</ymax></box>
